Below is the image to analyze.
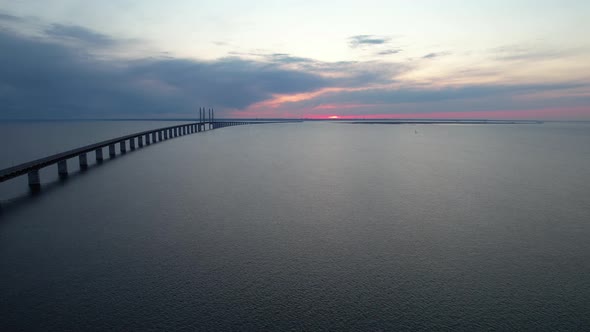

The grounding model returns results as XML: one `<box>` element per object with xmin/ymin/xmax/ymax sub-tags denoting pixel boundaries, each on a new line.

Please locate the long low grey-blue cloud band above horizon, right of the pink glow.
<box><xmin>264</xmin><ymin>83</ymin><xmax>590</xmax><ymax>117</ymax></box>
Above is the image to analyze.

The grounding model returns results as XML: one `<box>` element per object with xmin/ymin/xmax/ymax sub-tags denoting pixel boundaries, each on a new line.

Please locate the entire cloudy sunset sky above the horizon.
<box><xmin>0</xmin><ymin>0</ymin><xmax>590</xmax><ymax>120</ymax></box>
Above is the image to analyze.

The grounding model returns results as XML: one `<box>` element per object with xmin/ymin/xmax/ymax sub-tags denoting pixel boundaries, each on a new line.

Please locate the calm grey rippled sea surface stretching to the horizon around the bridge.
<box><xmin>0</xmin><ymin>122</ymin><xmax>590</xmax><ymax>331</ymax></box>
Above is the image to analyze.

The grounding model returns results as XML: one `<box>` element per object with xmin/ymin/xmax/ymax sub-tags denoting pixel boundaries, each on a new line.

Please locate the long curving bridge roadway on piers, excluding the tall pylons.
<box><xmin>0</xmin><ymin>120</ymin><xmax>278</xmax><ymax>189</ymax></box>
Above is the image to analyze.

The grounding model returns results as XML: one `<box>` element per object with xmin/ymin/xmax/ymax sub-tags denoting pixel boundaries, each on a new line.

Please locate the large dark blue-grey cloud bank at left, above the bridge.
<box><xmin>0</xmin><ymin>29</ymin><xmax>330</xmax><ymax>118</ymax></box>
